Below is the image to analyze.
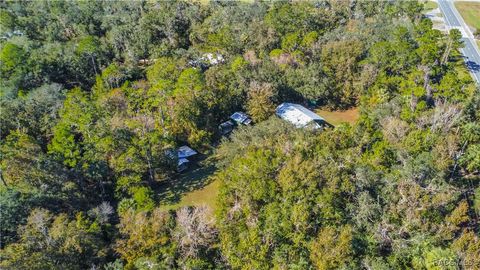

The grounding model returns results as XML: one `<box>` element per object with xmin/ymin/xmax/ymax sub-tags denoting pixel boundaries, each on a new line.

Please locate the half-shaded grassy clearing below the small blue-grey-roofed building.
<box><xmin>156</xmin><ymin>157</ymin><xmax>220</xmax><ymax>210</ymax></box>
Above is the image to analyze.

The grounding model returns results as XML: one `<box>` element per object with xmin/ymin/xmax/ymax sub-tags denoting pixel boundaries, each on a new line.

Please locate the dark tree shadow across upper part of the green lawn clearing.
<box><xmin>155</xmin><ymin>157</ymin><xmax>216</xmax><ymax>205</ymax></box>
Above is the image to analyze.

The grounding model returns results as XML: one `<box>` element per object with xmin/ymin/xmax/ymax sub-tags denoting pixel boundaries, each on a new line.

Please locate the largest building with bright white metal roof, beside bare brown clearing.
<box><xmin>275</xmin><ymin>102</ymin><xmax>326</xmax><ymax>129</ymax></box>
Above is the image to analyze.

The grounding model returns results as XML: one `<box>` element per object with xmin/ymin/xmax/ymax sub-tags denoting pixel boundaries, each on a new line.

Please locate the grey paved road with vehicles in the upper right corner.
<box><xmin>438</xmin><ymin>0</ymin><xmax>480</xmax><ymax>84</ymax></box>
